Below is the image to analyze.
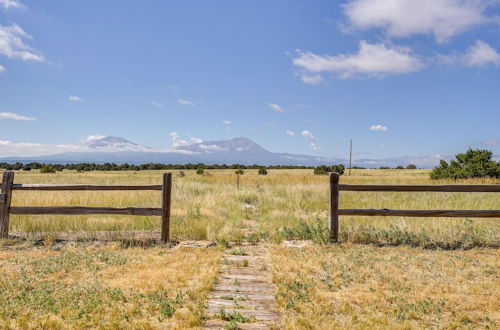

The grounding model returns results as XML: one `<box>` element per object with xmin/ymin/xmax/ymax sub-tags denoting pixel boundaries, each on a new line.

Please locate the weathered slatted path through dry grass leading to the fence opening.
<box><xmin>204</xmin><ymin>222</ymin><xmax>279</xmax><ymax>329</ymax></box>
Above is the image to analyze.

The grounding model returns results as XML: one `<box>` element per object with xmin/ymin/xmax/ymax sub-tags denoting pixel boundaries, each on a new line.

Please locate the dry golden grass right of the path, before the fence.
<box><xmin>271</xmin><ymin>244</ymin><xmax>500</xmax><ymax>329</ymax></box>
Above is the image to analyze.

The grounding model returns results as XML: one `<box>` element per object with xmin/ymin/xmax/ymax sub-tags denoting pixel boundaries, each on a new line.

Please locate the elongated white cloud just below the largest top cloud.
<box><xmin>293</xmin><ymin>41</ymin><xmax>424</xmax><ymax>78</ymax></box>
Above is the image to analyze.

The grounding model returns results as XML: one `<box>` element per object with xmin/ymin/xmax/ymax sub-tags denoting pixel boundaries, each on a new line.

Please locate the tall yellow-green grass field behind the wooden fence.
<box><xmin>10</xmin><ymin>170</ymin><xmax>500</xmax><ymax>249</ymax></box>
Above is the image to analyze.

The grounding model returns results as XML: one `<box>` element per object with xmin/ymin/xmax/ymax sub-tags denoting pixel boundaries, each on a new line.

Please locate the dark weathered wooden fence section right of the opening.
<box><xmin>329</xmin><ymin>173</ymin><xmax>500</xmax><ymax>242</ymax></box>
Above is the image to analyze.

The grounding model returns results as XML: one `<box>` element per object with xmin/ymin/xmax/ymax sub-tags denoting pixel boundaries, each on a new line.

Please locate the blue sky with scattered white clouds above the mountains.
<box><xmin>0</xmin><ymin>0</ymin><xmax>500</xmax><ymax>158</ymax></box>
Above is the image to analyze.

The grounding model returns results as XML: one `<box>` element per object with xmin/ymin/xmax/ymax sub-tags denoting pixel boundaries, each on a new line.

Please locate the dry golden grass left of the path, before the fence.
<box><xmin>0</xmin><ymin>244</ymin><xmax>221</xmax><ymax>329</ymax></box>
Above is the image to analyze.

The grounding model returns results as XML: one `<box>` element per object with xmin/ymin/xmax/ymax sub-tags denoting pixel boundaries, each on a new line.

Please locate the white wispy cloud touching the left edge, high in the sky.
<box><xmin>0</xmin><ymin>24</ymin><xmax>45</xmax><ymax>62</ymax></box>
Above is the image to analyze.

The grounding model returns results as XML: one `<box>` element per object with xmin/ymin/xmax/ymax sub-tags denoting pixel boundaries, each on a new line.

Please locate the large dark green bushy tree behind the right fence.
<box><xmin>430</xmin><ymin>148</ymin><xmax>500</xmax><ymax>180</ymax></box>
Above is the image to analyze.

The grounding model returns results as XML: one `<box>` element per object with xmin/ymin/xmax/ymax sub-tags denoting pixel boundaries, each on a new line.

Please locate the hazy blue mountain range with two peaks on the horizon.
<box><xmin>0</xmin><ymin>136</ymin><xmax>446</xmax><ymax>168</ymax></box>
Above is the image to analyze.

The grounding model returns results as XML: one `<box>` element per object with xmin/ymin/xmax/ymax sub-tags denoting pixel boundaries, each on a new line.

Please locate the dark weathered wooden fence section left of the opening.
<box><xmin>0</xmin><ymin>172</ymin><xmax>172</xmax><ymax>242</ymax></box>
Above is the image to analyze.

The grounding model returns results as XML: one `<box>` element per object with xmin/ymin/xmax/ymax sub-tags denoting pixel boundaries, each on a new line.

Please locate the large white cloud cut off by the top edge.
<box><xmin>343</xmin><ymin>0</ymin><xmax>498</xmax><ymax>42</ymax></box>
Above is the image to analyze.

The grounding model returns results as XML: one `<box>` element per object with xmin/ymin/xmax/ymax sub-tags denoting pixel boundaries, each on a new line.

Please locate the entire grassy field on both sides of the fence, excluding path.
<box><xmin>0</xmin><ymin>170</ymin><xmax>500</xmax><ymax>329</ymax></box>
